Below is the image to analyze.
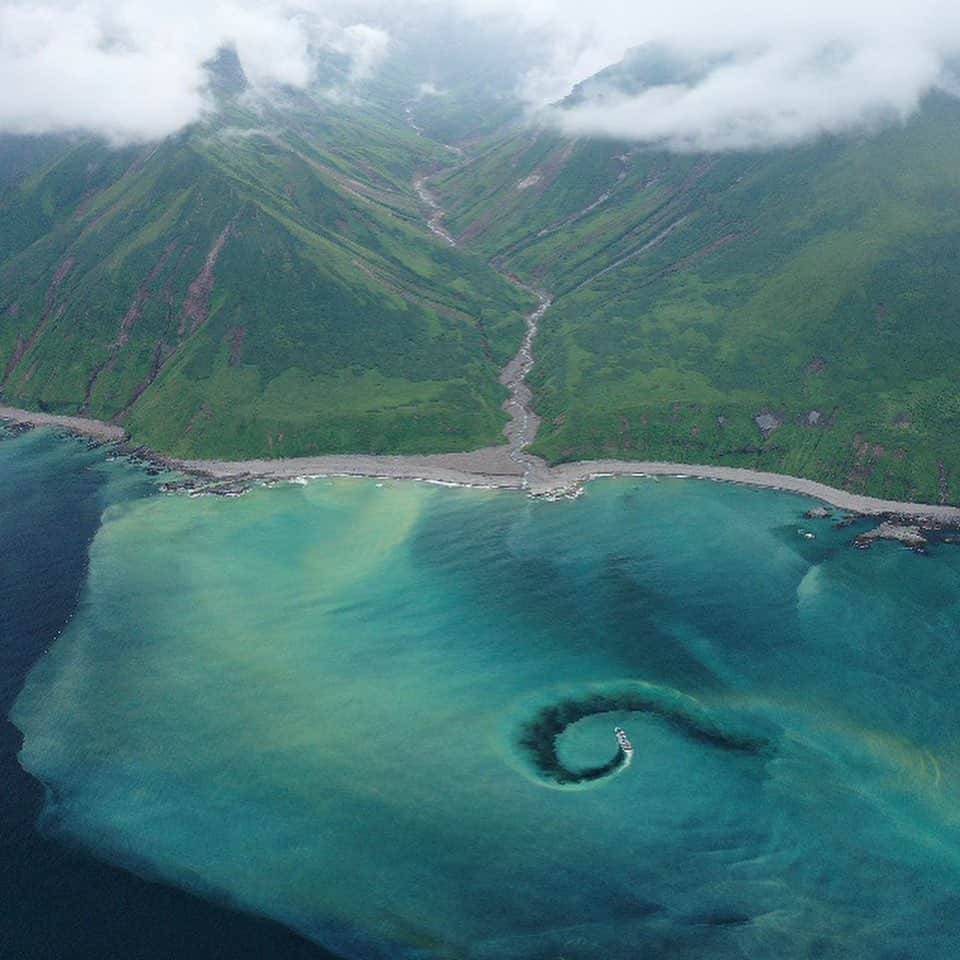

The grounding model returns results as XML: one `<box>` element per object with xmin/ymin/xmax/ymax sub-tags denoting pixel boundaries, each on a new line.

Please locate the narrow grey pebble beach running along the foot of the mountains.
<box><xmin>0</xmin><ymin>406</ymin><xmax>960</xmax><ymax>526</ymax></box>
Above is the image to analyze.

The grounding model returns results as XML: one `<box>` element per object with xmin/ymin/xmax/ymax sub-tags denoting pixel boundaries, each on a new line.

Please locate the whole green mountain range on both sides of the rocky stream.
<box><xmin>0</xmin><ymin>42</ymin><xmax>960</xmax><ymax>503</ymax></box>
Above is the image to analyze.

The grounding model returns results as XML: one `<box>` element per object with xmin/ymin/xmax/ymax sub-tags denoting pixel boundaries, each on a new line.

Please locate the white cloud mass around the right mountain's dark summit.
<box><xmin>448</xmin><ymin>0</ymin><xmax>960</xmax><ymax>150</ymax></box>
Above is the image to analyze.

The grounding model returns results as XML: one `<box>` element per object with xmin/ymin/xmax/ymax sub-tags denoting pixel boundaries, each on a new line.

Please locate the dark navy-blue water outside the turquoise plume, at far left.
<box><xmin>0</xmin><ymin>432</ymin><xmax>342</xmax><ymax>960</ymax></box>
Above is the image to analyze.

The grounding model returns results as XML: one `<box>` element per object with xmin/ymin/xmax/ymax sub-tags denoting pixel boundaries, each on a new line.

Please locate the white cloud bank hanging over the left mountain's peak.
<box><xmin>0</xmin><ymin>0</ymin><xmax>388</xmax><ymax>143</ymax></box>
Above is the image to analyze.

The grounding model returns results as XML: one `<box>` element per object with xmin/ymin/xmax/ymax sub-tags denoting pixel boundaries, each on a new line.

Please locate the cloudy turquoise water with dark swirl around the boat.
<box><xmin>13</xmin><ymin>460</ymin><xmax>960</xmax><ymax>960</ymax></box>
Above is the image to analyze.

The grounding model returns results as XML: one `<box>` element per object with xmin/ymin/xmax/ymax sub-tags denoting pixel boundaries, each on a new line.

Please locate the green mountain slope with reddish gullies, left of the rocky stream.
<box><xmin>0</xmin><ymin>105</ymin><xmax>528</xmax><ymax>457</ymax></box>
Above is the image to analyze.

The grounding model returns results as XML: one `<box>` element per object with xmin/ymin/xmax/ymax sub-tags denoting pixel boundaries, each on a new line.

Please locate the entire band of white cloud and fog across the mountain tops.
<box><xmin>0</xmin><ymin>0</ymin><xmax>960</xmax><ymax>151</ymax></box>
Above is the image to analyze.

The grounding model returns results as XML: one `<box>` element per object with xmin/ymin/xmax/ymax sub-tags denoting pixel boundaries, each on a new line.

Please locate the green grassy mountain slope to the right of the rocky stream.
<box><xmin>439</xmin><ymin>100</ymin><xmax>960</xmax><ymax>503</ymax></box>
